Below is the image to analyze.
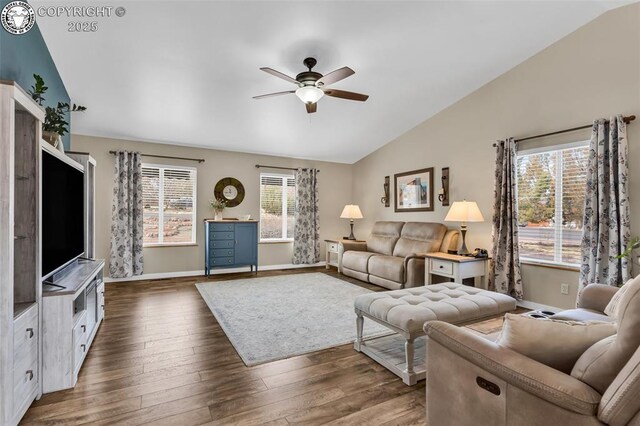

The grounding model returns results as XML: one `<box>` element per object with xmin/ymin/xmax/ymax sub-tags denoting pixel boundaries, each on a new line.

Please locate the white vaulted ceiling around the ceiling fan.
<box><xmin>31</xmin><ymin>0</ymin><xmax>628</xmax><ymax>163</ymax></box>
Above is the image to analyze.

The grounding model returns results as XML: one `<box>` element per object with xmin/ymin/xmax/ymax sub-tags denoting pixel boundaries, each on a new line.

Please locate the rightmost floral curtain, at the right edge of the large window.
<box><xmin>580</xmin><ymin>115</ymin><xmax>631</xmax><ymax>290</ymax></box>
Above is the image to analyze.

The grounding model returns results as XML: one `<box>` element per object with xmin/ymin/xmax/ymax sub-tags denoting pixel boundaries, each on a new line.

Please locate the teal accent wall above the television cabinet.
<box><xmin>0</xmin><ymin>0</ymin><xmax>71</xmax><ymax>149</ymax></box>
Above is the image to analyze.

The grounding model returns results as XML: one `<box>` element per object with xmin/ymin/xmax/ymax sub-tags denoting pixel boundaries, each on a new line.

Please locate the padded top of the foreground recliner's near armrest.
<box><xmin>425</xmin><ymin>321</ymin><xmax>602</xmax><ymax>415</ymax></box>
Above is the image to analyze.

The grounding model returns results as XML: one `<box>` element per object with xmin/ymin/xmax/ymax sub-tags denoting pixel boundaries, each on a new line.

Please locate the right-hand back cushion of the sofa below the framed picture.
<box><xmin>393</xmin><ymin>222</ymin><xmax>447</xmax><ymax>257</ymax></box>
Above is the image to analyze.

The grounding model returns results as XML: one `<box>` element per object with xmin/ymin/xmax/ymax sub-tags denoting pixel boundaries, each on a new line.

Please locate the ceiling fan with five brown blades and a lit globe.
<box><xmin>253</xmin><ymin>58</ymin><xmax>369</xmax><ymax>114</ymax></box>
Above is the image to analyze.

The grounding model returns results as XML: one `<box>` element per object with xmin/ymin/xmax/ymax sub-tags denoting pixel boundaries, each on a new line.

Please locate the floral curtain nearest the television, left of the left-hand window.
<box><xmin>109</xmin><ymin>151</ymin><xmax>143</xmax><ymax>278</ymax></box>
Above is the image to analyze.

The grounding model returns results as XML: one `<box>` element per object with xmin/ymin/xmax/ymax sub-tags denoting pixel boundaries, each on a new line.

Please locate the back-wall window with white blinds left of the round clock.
<box><xmin>142</xmin><ymin>164</ymin><xmax>196</xmax><ymax>246</ymax></box>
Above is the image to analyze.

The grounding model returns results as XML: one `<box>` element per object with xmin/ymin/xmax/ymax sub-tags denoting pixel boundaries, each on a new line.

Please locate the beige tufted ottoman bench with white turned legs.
<box><xmin>354</xmin><ymin>283</ymin><xmax>516</xmax><ymax>386</ymax></box>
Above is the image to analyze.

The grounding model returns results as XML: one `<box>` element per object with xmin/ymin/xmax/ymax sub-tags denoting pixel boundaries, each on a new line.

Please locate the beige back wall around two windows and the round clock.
<box><xmin>71</xmin><ymin>135</ymin><xmax>352</xmax><ymax>274</ymax></box>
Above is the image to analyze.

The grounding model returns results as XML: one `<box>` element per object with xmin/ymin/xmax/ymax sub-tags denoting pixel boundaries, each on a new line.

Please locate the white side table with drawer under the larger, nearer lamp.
<box><xmin>424</xmin><ymin>252</ymin><xmax>489</xmax><ymax>290</ymax></box>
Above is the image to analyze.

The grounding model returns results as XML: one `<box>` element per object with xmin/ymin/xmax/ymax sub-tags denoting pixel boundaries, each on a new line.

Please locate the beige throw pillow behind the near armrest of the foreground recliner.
<box><xmin>496</xmin><ymin>314</ymin><xmax>616</xmax><ymax>374</ymax></box>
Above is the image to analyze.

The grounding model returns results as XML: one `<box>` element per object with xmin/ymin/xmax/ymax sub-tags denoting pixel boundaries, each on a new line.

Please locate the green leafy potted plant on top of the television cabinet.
<box><xmin>29</xmin><ymin>74</ymin><xmax>87</xmax><ymax>150</ymax></box>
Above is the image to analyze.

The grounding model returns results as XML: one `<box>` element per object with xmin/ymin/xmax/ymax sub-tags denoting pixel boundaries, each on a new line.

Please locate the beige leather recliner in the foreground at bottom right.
<box><xmin>425</xmin><ymin>277</ymin><xmax>640</xmax><ymax>426</ymax></box>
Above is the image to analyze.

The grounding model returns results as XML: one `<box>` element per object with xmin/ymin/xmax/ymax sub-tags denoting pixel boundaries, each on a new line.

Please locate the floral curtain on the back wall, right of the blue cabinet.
<box><xmin>292</xmin><ymin>169</ymin><xmax>320</xmax><ymax>264</ymax></box>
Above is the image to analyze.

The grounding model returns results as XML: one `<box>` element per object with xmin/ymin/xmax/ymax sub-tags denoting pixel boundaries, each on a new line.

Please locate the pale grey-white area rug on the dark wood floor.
<box><xmin>196</xmin><ymin>272</ymin><xmax>390</xmax><ymax>366</ymax></box>
